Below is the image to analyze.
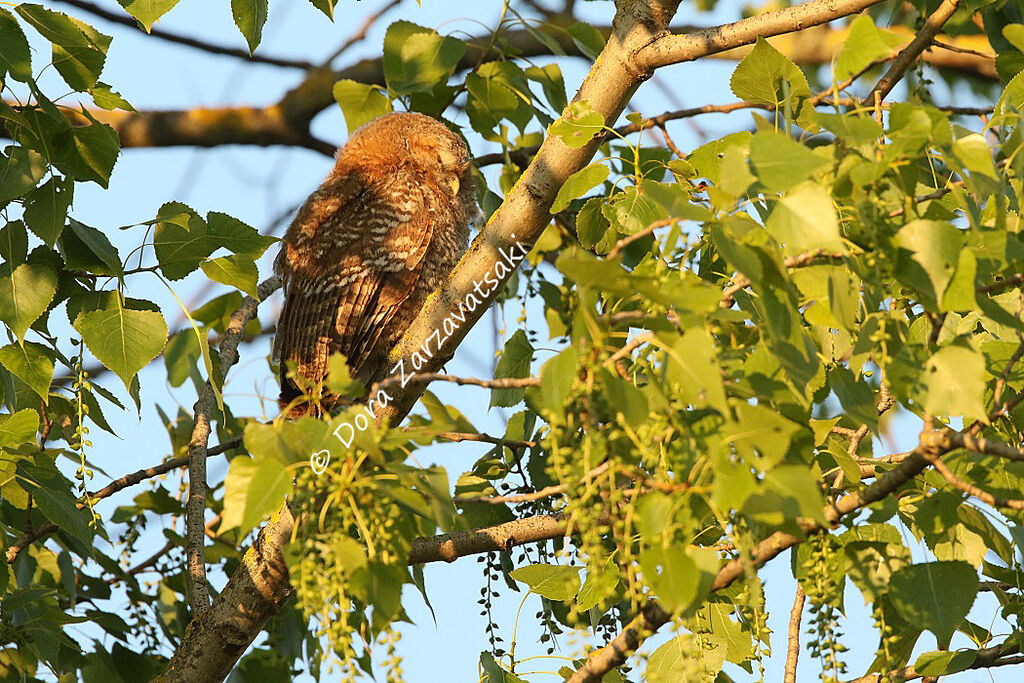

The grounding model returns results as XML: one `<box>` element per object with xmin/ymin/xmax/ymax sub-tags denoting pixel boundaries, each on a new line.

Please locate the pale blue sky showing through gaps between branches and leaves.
<box><xmin>8</xmin><ymin>0</ymin><xmax>1012</xmax><ymax>682</ymax></box>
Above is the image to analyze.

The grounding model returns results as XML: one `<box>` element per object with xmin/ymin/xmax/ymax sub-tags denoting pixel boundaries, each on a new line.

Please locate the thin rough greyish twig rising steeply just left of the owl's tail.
<box><xmin>185</xmin><ymin>276</ymin><xmax>281</xmax><ymax>618</ymax></box>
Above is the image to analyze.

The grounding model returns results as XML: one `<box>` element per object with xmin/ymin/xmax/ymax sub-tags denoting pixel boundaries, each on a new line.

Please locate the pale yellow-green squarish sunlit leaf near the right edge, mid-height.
<box><xmin>924</xmin><ymin>346</ymin><xmax>986</xmax><ymax>418</ymax></box>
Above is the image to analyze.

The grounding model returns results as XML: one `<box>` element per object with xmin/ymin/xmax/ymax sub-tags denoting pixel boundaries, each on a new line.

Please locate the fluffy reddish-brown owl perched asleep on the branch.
<box><xmin>273</xmin><ymin>113</ymin><xmax>479</xmax><ymax>417</ymax></box>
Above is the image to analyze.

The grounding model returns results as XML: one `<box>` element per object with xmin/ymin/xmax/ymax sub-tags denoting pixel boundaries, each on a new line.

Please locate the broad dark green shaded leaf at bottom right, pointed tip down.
<box><xmin>888</xmin><ymin>561</ymin><xmax>978</xmax><ymax>647</ymax></box>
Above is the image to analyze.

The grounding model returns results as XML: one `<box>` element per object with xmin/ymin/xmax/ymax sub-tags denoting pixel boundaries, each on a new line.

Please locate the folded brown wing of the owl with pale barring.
<box><xmin>275</xmin><ymin>174</ymin><xmax>432</xmax><ymax>389</ymax></box>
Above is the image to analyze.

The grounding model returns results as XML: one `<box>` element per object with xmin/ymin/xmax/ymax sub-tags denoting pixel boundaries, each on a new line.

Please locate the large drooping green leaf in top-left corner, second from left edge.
<box><xmin>14</xmin><ymin>3</ymin><xmax>111</xmax><ymax>92</ymax></box>
